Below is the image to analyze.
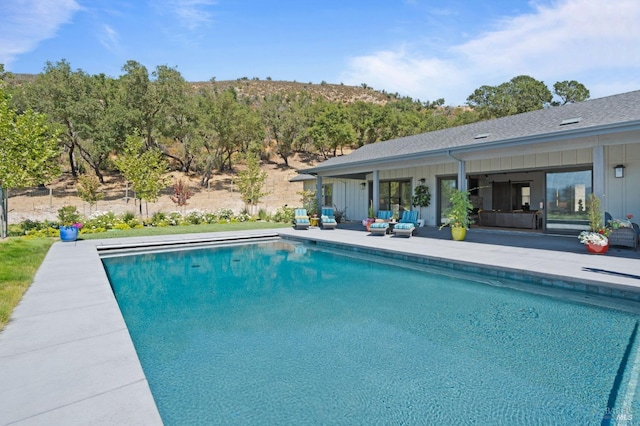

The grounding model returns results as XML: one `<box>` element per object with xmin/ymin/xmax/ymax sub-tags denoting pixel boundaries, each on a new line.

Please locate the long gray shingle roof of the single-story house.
<box><xmin>304</xmin><ymin>90</ymin><xmax>640</xmax><ymax>173</ymax></box>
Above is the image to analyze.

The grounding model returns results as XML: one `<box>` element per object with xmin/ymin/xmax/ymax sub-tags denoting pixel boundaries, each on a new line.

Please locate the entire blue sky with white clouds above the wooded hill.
<box><xmin>0</xmin><ymin>0</ymin><xmax>640</xmax><ymax>106</ymax></box>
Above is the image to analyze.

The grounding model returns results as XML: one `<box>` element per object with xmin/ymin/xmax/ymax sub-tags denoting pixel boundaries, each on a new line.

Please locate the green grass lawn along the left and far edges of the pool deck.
<box><xmin>0</xmin><ymin>222</ymin><xmax>291</xmax><ymax>330</ymax></box>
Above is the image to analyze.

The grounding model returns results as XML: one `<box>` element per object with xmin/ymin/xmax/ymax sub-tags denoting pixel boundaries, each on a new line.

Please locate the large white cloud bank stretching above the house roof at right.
<box><xmin>342</xmin><ymin>0</ymin><xmax>640</xmax><ymax>104</ymax></box>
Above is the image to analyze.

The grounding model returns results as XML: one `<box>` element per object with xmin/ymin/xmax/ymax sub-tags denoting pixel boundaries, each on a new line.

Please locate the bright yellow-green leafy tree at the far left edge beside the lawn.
<box><xmin>0</xmin><ymin>85</ymin><xmax>60</xmax><ymax>238</ymax></box>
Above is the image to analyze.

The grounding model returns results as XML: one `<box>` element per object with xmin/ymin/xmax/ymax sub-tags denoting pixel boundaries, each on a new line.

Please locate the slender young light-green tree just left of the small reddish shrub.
<box><xmin>115</xmin><ymin>136</ymin><xmax>168</xmax><ymax>214</ymax></box>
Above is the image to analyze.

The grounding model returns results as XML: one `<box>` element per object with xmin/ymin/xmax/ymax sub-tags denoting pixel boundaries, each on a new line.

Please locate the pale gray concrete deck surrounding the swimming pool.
<box><xmin>0</xmin><ymin>227</ymin><xmax>640</xmax><ymax>425</ymax></box>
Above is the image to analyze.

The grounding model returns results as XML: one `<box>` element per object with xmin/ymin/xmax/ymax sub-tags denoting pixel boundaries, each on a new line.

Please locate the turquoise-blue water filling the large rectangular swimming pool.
<box><xmin>103</xmin><ymin>242</ymin><xmax>640</xmax><ymax>425</ymax></box>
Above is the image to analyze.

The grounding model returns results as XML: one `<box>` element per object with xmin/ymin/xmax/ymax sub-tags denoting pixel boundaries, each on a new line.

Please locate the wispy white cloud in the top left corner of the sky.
<box><xmin>0</xmin><ymin>0</ymin><xmax>80</xmax><ymax>65</ymax></box>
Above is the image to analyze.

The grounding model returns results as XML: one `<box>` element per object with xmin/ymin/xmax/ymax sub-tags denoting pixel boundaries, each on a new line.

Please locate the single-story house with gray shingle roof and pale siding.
<box><xmin>300</xmin><ymin>91</ymin><xmax>640</xmax><ymax>232</ymax></box>
